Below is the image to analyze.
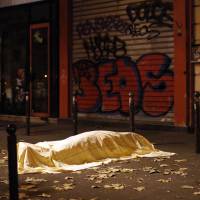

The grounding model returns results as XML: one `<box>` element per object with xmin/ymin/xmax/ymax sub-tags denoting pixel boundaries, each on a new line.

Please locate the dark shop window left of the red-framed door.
<box><xmin>0</xmin><ymin>27</ymin><xmax>27</xmax><ymax>115</ymax></box>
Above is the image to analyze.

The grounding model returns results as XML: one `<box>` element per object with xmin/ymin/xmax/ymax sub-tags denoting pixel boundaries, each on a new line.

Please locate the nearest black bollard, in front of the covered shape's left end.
<box><xmin>6</xmin><ymin>124</ymin><xmax>18</xmax><ymax>200</ymax></box>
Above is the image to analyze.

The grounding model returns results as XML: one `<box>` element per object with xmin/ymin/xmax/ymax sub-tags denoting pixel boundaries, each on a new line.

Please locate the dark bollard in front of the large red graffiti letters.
<box><xmin>129</xmin><ymin>91</ymin><xmax>135</xmax><ymax>132</ymax></box>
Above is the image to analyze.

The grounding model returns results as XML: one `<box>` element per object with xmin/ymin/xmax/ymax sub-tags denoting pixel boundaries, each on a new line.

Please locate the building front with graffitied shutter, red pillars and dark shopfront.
<box><xmin>0</xmin><ymin>0</ymin><xmax>195</xmax><ymax>127</ymax></box>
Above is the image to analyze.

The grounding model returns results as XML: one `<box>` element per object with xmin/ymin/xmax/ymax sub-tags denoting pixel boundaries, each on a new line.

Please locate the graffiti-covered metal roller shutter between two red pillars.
<box><xmin>73</xmin><ymin>0</ymin><xmax>174</xmax><ymax>121</ymax></box>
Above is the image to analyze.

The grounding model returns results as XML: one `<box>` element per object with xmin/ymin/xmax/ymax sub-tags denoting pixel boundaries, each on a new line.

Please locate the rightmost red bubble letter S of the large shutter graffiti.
<box><xmin>137</xmin><ymin>54</ymin><xmax>174</xmax><ymax>116</ymax></box>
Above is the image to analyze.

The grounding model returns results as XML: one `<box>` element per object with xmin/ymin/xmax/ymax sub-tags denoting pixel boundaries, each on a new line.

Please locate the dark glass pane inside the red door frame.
<box><xmin>31</xmin><ymin>27</ymin><xmax>49</xmax><ymax>113</ymax></box>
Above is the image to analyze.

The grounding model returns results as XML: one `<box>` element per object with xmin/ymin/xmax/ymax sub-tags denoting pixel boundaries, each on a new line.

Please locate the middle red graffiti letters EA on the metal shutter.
<box><xmin>98</xmin><ymin>57</ymin><xmax>141</xmax><ymax>113</ymax></box>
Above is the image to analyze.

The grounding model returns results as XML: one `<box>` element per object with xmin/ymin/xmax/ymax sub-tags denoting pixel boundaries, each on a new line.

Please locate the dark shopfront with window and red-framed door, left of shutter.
<box><xmin>0</xmin><ymin>0</ymin><xmax>59</xmax><ymax>118</ymax></box>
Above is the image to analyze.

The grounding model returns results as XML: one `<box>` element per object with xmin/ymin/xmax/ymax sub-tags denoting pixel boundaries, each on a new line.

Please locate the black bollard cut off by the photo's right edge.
<box><xmin>194</xmin><ymin>92</ymin><xmax>200</xmax><ymax>153</ymax></box>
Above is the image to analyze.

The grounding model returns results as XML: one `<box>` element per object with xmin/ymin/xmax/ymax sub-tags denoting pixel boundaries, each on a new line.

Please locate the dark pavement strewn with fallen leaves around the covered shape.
<box><xmin>0</xmin><ymin>122</ymin><xmax>200</xmax><ymax>200</ymax></box>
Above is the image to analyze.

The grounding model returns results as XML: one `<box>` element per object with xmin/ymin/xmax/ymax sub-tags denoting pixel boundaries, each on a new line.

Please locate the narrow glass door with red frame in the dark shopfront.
<box><xmin>30</xmin><ymin>23</ymin><xmax>50</xmax><ymax>117</ymax></box>
